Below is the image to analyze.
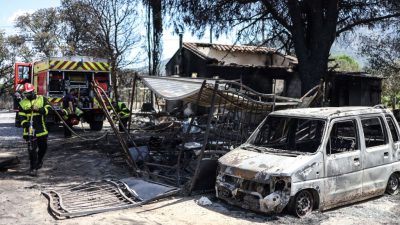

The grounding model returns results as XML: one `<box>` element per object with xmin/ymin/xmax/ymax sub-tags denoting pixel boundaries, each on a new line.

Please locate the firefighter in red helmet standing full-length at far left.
<box><xmin>18</xmin><ymin>83</ymin><xmax>51</xmax><ymax>176</ymax></box>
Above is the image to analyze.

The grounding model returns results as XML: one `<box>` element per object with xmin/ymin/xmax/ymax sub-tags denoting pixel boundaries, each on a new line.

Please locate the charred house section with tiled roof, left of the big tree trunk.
<box><xmin>166</xmin><ymin>42</ymin><xmax>300</xmax><ymax>97</ymax></box>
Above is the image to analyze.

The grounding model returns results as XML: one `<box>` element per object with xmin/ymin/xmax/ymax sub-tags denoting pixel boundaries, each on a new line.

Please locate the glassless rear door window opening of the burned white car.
<box><xmin>361</xmin><ymin>117</ymin><xmax>388</xmax><ymax>148</ymax></box>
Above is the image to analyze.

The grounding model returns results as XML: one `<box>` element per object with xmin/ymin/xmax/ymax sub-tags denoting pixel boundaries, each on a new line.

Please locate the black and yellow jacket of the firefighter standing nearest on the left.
<box><xmin>18</xmin><ymin>95</ymin><xmax>51</xmax><ymax>138</ymax></box>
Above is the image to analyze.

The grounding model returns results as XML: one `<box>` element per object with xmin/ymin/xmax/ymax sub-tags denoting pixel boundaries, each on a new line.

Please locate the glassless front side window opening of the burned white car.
<box><xmin>326</xmin><ymin>120</ymin><xmax>359</xmax><ymax>155</ymax></box>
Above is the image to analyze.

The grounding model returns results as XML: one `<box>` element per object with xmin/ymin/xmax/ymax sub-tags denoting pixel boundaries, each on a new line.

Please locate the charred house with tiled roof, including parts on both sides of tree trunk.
<box><xmin>166</xmin><ymin>42</ymin><xmax>382</xmax><ymax>106</ymax></box>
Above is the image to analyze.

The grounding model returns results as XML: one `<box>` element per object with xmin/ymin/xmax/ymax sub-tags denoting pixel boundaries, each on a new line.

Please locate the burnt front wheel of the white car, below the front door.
<box><xmin>289</xmin><ymin>190</ymin><xmax>314</xmax><ymax>218</ymax></box>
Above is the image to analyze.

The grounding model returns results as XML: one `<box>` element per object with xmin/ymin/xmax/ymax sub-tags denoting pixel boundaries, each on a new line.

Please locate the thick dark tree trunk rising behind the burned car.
<box><xmin>288</xmin><ymin>0</ymin><xmax>339</xmax><ymax>94</ymax></box>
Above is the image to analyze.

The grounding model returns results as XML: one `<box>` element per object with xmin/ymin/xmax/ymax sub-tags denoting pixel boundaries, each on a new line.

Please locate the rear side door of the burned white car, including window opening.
<box><xmin>361</xmin><ymin>115</ymin><xmax>393</xmax><ymax>197</ymax></box>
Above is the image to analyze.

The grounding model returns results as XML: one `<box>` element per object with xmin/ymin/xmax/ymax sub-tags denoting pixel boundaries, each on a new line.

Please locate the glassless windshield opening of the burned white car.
<box><xmin>247</xmin><ymin>115</ymin><xmax>327</xmax><ymax>154</ymax></box>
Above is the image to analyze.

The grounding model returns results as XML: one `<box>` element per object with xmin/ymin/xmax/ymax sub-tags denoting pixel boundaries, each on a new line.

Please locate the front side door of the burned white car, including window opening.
<box><xmin>324</xmin><ymin>117</ymin><xmax>363</xmax><ymax>207</ymax></box>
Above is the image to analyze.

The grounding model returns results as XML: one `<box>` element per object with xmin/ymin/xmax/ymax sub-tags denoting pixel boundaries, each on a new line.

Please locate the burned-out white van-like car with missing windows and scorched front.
<box><xmin>215</xmin><ymin>107</ymin><xmax>400</xmax><ymax>217</ymax></box>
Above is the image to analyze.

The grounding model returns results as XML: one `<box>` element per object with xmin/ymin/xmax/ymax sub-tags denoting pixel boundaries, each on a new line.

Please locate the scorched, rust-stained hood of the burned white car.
<box><xmin>218</xmin><ymin>148</ymin><xmax>315</xmax><ymax>180</ymax></box>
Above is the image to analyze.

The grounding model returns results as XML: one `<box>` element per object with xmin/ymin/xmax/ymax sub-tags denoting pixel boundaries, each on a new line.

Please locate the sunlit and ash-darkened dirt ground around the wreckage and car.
<box><xmin>0</xmin><ymin>112</ymin><xmax>400</xmax><ymax>225</ymax></box>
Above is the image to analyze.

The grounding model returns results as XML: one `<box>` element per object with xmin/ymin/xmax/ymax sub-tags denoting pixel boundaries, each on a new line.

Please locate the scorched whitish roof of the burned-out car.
<box><xmin>270</xmin><ymin>106</ymin><xmax>390</xmax><ymax>119</ymax></box>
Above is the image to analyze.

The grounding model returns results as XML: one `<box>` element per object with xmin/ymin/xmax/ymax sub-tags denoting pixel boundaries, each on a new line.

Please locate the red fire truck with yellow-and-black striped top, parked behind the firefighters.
<box><xmin>14</xmin><ymin>56</ymin><xmax>111</xmax><ymax>130</ymax></box>
